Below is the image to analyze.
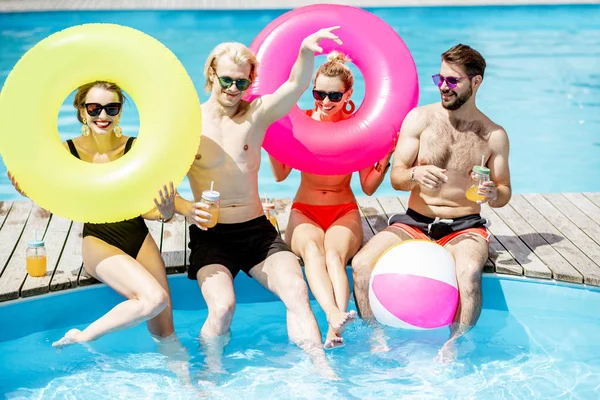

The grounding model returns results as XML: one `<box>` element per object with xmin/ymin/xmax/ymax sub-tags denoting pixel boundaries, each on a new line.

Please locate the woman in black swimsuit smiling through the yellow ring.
<box><xmin>9</xmin><ymin>81</ymin><xmax>206</xmax><ymax>362</ymax></box>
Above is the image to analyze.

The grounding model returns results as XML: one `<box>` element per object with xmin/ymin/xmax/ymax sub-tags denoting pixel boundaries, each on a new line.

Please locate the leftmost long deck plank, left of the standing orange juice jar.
<box><xmin>0</xmin><ymin>201</ymin><xmax>33</xmax><ymax>282</ymax></box>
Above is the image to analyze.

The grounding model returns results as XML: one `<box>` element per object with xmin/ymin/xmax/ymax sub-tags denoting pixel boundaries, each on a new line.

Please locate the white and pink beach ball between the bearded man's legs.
<box><xmin>369</xmin><ymin>240</ymin><xmax>458</xmax><ymax>329</ymax></box>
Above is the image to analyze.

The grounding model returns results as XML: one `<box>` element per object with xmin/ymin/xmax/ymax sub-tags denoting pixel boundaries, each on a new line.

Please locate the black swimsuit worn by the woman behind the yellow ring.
<box><xmin>67</xmin><ymin>138</ymin><xmax>148</xmax><ymax>258</ymax></box>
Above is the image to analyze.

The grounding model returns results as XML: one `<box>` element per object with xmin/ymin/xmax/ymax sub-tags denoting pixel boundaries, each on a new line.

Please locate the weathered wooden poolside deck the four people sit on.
<box><xmin>0</xmin><ymin>193</ymin><xmax>600</xmax><ymax>302</ymax></box>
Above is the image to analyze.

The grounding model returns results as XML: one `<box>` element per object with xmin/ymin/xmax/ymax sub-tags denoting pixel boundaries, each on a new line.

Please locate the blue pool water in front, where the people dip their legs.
<box><xmin>0</xmin><ymin>275</ymin><xmax>600</xmax><ymax>399</ymax></box>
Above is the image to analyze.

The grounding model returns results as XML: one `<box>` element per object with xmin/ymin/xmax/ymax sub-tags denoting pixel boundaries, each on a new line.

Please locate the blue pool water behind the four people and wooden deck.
<box><xmin>0</xmin><ymin>5</ymin><xmax>600</xmax><ymax>200</ymax></box>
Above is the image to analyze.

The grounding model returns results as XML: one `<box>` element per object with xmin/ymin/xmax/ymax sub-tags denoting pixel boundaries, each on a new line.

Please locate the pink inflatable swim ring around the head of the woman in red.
<box><xmin>250</xmin><ymin>4</ymin><xmax>419</xmax><ymax>175</ymax></box>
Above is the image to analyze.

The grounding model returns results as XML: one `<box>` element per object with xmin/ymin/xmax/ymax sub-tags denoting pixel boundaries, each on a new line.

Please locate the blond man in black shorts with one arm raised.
<box><xmin>176</xmin><ymin>27</ymin><xmax>341</xmax><ymax>376</ymax></box>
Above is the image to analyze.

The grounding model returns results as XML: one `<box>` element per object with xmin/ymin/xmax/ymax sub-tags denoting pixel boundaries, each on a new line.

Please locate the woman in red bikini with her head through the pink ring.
<box><xmin>271</xmin><ymin>51</ymin><xmax>393</xmax><ymax>349</ymax></box>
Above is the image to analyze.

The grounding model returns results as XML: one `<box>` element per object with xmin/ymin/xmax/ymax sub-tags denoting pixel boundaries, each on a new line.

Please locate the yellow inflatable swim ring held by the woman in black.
<box><xmin>0</xmin><ymin>24</ymin><xmax>201</xmax><ymax>222</ymax></box>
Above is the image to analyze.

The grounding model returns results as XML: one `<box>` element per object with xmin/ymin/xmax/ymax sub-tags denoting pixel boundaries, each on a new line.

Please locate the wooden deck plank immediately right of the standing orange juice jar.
<box><xmin>20</xmin><ymin>215</ymin><xmax>71</xmax><ymax>297</ymax></box>
